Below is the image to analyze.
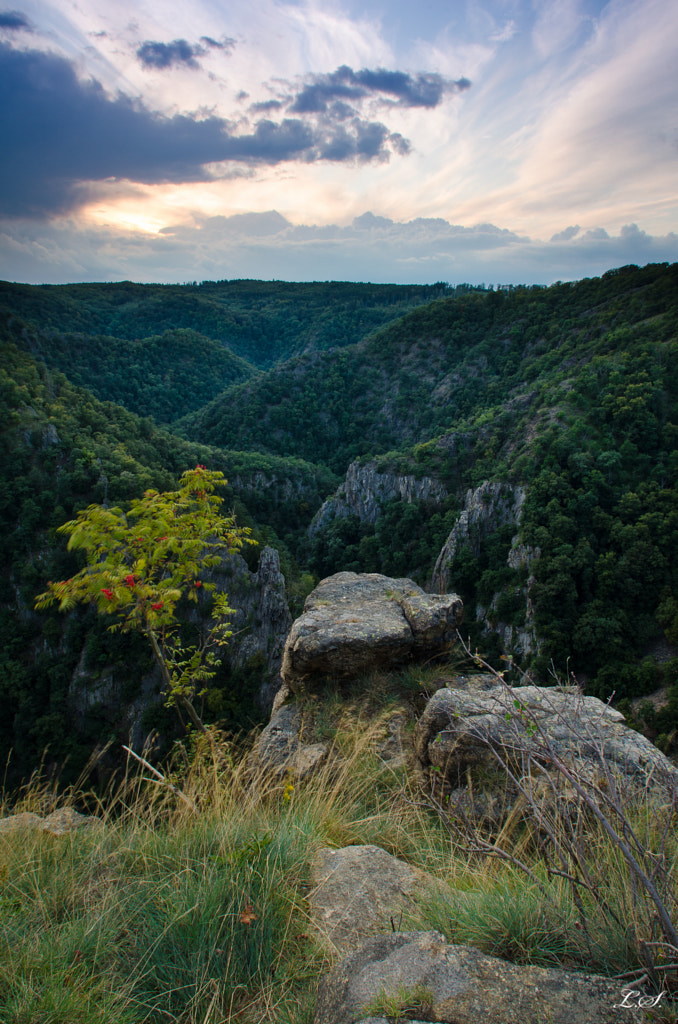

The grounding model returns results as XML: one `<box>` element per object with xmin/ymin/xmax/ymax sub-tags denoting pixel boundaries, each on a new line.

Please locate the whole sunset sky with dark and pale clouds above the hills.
<box><xmin>0</xmin><ymin>0</ymin><xmax>678</xmax><ymax>285</ymax></box>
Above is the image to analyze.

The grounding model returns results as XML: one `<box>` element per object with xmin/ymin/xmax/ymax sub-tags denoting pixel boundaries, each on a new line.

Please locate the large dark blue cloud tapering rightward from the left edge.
<box><xmin>0</xmin><ymin>44</ymin><xmax>408</xmax><ymax>217</ymax></box>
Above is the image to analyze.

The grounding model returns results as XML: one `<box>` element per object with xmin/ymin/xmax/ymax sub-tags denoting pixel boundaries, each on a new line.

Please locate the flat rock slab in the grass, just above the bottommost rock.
<box><xmin>308</xmin><ymin>846</ymin><xmax>441</xmax><ymax>953</ymax></box>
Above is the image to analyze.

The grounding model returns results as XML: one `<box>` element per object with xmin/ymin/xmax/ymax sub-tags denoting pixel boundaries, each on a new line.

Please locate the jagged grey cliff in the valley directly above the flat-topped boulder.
<box><xmin>308</xmin><ymin>462</ymin><xmax>448</xmax><ymax>537</ymax></box>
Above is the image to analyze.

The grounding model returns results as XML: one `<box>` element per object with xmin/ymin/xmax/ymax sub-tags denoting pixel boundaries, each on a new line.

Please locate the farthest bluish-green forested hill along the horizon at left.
<box><xmin>0</xmin><ymin>281</ymin><xmax>450</xmax><ymax>372</ymax></box>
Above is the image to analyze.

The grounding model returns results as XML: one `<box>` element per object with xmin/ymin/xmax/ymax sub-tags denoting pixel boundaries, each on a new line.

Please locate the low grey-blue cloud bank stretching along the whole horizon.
<box><xmin>0</xmin><ymin>210</ymin><xmax>678</xmax><ymax>284</ymax></box>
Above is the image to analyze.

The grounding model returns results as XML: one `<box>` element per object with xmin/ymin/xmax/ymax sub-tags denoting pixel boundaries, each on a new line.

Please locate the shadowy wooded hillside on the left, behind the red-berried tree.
<box><xmin>0</xmin><ymin>322</ymin><xmax>336</xmax><ymax>778</ymax></box>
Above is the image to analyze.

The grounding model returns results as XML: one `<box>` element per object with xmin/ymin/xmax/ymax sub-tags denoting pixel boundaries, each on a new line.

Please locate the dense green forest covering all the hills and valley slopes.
<box><xmin>0</xmin><ymin>264</ymin><xmax>678</xmax><ymax>771</ymax></box>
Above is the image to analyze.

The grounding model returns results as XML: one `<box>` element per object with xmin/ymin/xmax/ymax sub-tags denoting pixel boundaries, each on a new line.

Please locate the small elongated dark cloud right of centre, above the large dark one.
<box><xmin>290</xmin><ymin>65</ymin><xmax>471</xmax><ymax>114</ymax></box>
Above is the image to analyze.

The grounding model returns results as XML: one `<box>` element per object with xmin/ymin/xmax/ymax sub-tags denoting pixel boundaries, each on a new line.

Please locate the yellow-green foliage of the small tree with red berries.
<box><xmin>36</xmin><ymin>465</ymin><xmax>252</xmax><ymax>730</ymax></box>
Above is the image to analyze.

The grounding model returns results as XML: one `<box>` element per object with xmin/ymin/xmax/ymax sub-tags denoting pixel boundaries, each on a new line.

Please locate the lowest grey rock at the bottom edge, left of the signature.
<box><xmin>313</xmin><ymin>932</ymin><xmax>642</xmax><ymax>1024</ymax></box>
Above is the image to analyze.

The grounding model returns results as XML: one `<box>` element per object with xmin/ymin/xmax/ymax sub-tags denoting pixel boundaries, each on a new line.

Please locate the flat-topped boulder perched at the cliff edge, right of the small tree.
<box><xmin>282</xmin><ymin>572</ymin><xmax>463</xmax><ymax>690</ymax></box>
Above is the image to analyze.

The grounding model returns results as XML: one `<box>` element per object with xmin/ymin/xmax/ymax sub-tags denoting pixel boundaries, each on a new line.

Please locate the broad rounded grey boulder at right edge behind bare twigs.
<box><xmin>415</xmin><ymin>676</ymin><xmax>678</xmax><ymax>790</ymax></box>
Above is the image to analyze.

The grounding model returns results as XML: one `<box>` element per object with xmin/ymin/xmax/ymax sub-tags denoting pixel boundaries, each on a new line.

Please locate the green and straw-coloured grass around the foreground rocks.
<box><xmin>0</xmin><ymin>704</ymin><xmax>677</xmax><ymax>1024</ymax></box>
